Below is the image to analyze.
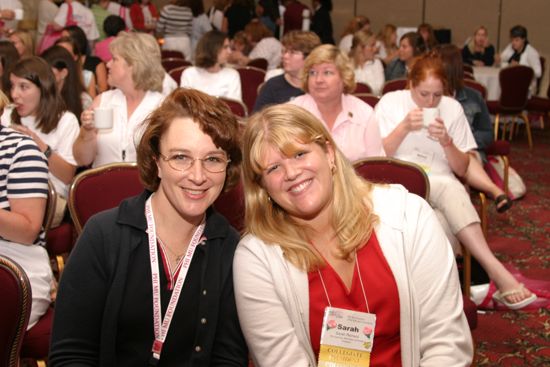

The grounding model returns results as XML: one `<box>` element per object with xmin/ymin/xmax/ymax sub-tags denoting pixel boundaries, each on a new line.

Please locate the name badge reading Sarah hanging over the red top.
<box><xmin>318</xmin><ymin>307</ymin><xmax>376</xmax><ymax>367</ymax></box>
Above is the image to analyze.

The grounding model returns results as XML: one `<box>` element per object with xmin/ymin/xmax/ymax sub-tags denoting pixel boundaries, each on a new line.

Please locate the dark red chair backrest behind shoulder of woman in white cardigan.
<box><xmin>353</xmin><ymin>157</ymin><xmax>430</xmax><ymax>199</ymax></box>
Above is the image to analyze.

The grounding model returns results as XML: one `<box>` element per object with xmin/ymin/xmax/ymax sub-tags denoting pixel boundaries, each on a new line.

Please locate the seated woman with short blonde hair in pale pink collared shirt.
<box><xmin>289</xmin><ymin>44</ymin><xmax>386</xmax><ymax>161</ymax></box>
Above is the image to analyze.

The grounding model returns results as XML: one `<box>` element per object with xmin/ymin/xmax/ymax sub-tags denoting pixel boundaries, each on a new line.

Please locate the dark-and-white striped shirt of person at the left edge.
<box><xmin>0</xmin><ymin>126</ymin><xmax>48</xmax><ymax>246</ymax></box>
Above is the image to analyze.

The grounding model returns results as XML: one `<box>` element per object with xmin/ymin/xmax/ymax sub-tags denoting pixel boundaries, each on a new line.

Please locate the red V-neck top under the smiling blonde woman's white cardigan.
<box><xmin>308</xmin><ymin>232</ymin><xmax>401</xmax><ymax>366</ymax></box>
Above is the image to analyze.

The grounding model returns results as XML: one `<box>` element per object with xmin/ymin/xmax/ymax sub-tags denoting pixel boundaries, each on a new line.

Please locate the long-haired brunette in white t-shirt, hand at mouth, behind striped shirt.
<box><xmin>2</xmin><ymin>56</ymin><xmax>78</xmax><ymax>226</ymax></box>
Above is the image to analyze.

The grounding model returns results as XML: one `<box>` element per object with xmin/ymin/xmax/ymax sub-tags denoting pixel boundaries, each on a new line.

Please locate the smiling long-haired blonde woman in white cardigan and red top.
<box><xmin>233</xmin><ymin>104</ymin><xmax>472</xmax><ymax>367</ymax></box>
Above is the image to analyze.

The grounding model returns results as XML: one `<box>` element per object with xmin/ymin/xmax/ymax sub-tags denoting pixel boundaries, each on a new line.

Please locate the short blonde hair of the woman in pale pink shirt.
<box><xmin>301</xmin><ymin>44</ymin><xmax>355</xmax><ymax>94</ymax></box>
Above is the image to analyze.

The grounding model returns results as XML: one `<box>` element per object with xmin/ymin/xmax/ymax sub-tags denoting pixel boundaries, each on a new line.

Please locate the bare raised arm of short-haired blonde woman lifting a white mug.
<box><xmin>73</xmin><ymin>94</ymin><xmax>101</xmax><ymax>166</ymax></box>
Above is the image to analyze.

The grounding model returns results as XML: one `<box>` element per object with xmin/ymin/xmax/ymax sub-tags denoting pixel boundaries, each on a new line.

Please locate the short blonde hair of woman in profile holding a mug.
<box><xmin>109</xmin><ymin>32</ymin><xmax>164</xmax><ymax>92</ymax></box>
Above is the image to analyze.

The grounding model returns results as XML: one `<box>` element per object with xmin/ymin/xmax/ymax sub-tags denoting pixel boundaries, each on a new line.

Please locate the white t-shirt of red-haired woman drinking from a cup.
<box><xmin>374</xmin><ymin>90</ymin><xmax>477</xmax><ymax>177</ymax></box>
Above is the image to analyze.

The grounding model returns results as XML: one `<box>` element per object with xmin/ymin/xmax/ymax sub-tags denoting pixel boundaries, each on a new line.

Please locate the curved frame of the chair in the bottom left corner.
<box><xmin>0</xmin><ymin>256</ymin><xmax>32</xmax><ymax>367</ymax></box>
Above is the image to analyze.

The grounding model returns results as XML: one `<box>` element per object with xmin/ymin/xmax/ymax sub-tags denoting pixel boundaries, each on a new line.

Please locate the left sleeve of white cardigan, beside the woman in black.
<box><xmin>233</xmin><ymin>236</ymin><xmax>312</xmax><ymax>367</ymax></box>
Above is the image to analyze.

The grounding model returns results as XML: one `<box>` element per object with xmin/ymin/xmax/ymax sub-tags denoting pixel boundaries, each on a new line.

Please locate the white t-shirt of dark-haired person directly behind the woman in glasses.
<box><xmin>180</xmin><ymin>66</ymin><xmax>242</xmax><ymax>101</ymax></box>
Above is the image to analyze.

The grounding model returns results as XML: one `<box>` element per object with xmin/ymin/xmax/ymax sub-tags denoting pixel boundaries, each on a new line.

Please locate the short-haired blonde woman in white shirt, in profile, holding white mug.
<box><xmin>74</xmin><ymin>32</ymin><xmax>164</xmax><ymax>167</ymax></box>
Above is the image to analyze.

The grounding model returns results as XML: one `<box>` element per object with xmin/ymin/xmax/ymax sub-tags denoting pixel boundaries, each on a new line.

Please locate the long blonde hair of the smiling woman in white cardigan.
<box><xmin>242</xmin><ymin>104</ymin><xmax>378</xmax><ymax>271</ymax></box>
